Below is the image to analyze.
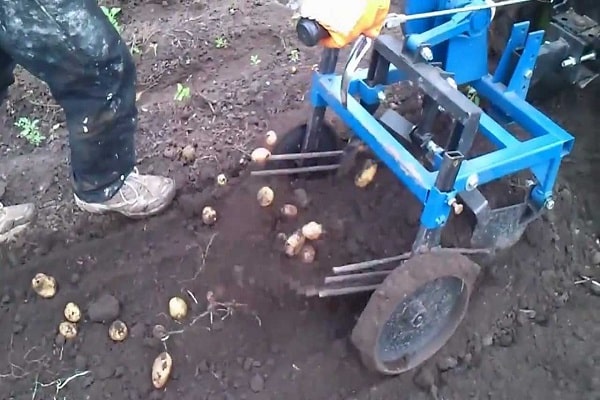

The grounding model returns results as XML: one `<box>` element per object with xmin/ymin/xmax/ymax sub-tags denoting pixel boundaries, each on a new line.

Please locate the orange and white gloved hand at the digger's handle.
<box><xmin>300</xmin><ymin>0</ymin><xmax>390</xmax><ymax>48</ymax></box>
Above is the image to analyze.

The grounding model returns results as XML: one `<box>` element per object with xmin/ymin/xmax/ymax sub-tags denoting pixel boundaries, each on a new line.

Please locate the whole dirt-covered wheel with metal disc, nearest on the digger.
<box><xmin>351</xmin><ymin>253</ymin><xmax>480</xmax><ymax>375</ymax></box>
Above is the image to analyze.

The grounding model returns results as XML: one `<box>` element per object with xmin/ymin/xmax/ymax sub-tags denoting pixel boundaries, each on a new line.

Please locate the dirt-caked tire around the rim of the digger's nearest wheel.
<box><xmin>351</xmin><ymin>253</ymin><xmax>481</xmax><ymax>375</ymax></box>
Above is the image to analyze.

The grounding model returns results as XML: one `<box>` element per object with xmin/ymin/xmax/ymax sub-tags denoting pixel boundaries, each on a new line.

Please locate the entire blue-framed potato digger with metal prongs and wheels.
<box><xmin>253</xmin><ymin>0</ymin><xmax>600</xmax><ymax>375</ymax></box>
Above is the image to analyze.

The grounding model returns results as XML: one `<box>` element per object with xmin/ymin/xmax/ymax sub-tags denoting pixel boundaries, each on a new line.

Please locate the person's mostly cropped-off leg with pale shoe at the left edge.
<box><xmin>0</xmin><ymin>48</ymin><xmax>35</xmax><ymax>244</ymax></box>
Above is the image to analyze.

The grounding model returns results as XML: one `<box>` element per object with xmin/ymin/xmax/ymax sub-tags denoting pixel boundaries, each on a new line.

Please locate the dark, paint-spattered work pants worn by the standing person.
<box><xmin>0</xmin><ymin>0</ymin><xmax>137</xmax><ymax>202</ymax></box>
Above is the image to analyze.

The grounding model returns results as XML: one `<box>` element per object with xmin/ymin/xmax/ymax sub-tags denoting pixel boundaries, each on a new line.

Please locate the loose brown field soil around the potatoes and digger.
<box><xmin>0</xmin><ymin>0</ymin><xmax>600</xmax><ymax>400</ymax></box>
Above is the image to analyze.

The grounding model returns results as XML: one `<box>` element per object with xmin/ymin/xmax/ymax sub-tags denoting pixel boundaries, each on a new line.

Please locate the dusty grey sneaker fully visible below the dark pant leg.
<box><xmin>75</xmin><ymin>169</ymin><xmax>176</xmax><ymax>219</ymax></box>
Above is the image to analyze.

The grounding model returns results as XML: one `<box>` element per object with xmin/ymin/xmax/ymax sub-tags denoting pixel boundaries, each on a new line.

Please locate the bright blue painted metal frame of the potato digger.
<box><xmin>310</xmin><ymin>0</ymin><xmax>574</xmax><ymax>229</ymax></box>
